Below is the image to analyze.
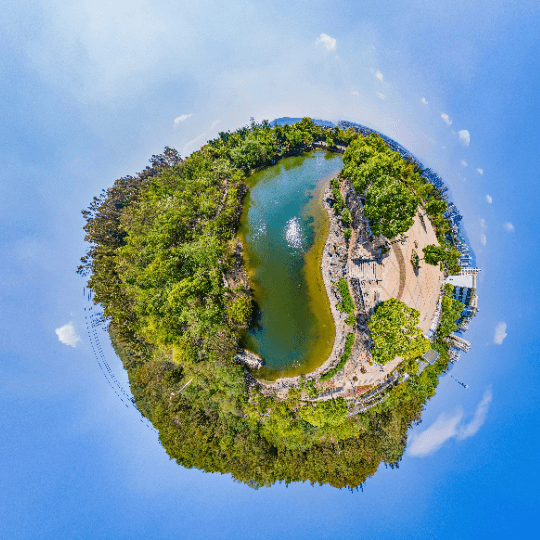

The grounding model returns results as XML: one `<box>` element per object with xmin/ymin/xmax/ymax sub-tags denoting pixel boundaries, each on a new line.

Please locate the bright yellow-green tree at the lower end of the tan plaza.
<box><xmin>368</xmin><ymin>298</ymin><xmax>430</xmax><ymax>364</ymax></box>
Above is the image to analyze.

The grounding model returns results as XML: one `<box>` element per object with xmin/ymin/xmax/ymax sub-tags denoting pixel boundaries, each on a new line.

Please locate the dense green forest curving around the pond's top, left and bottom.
<box><xmin>79</xmin><ymin>118</ymin><xmax>456</xmax><ymax>488</ymax></box>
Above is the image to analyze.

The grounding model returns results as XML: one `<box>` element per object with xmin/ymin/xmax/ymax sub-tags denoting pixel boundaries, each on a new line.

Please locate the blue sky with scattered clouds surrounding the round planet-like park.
<box><xmin>0</xmin><ymin>0</ymin><xmax>540</xmax><ymax>539</ymax></box>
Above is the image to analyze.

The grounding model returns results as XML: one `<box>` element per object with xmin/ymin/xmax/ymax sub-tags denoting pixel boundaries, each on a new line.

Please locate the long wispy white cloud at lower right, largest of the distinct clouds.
<box><xmin>409</xmin><ymin>388</ymin><xmax>493</xmax><ymax>457</ymax></box>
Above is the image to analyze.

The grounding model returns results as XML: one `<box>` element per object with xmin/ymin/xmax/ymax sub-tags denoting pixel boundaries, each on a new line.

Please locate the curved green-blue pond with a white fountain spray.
<box><xmin>239</xmin><ymin>151</ymin><xmax>343</xmax><ymax>380</ymax></box>
